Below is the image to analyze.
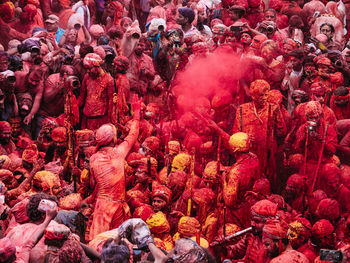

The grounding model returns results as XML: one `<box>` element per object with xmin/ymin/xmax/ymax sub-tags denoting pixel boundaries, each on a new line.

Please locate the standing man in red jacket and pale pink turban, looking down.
<box><xmin>78</xmin><ymin>53</ymin><xmax>114</xmax><ymax>130</ymax></box>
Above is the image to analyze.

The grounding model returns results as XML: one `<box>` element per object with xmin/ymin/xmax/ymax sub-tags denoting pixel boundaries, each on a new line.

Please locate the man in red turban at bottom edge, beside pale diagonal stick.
<box><xmin>214</xmin><ymin>199</ymin><xmax>277</xmax><ymax>263</ymax></box>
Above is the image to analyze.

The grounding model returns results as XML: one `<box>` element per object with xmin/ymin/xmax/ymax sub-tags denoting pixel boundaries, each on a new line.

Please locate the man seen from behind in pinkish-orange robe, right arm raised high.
<box><xmin>86</xmin><ymin>97</ymin><xmax>141</xmax><ymax>240</ymax></box>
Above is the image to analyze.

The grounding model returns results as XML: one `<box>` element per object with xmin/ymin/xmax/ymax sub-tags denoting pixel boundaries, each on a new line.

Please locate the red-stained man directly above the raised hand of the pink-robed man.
<box><xmin>127</xmin><ymin>37</ymin><xmax>155</xmax><ymax>99</ymax></box>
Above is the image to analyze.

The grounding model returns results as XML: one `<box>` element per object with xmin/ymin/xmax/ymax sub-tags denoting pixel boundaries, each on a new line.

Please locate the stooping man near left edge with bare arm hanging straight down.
<box><xmin>15</xmin><ymin>65</ymin><xmax>44</xmax><ymax>129</ymax></box>
